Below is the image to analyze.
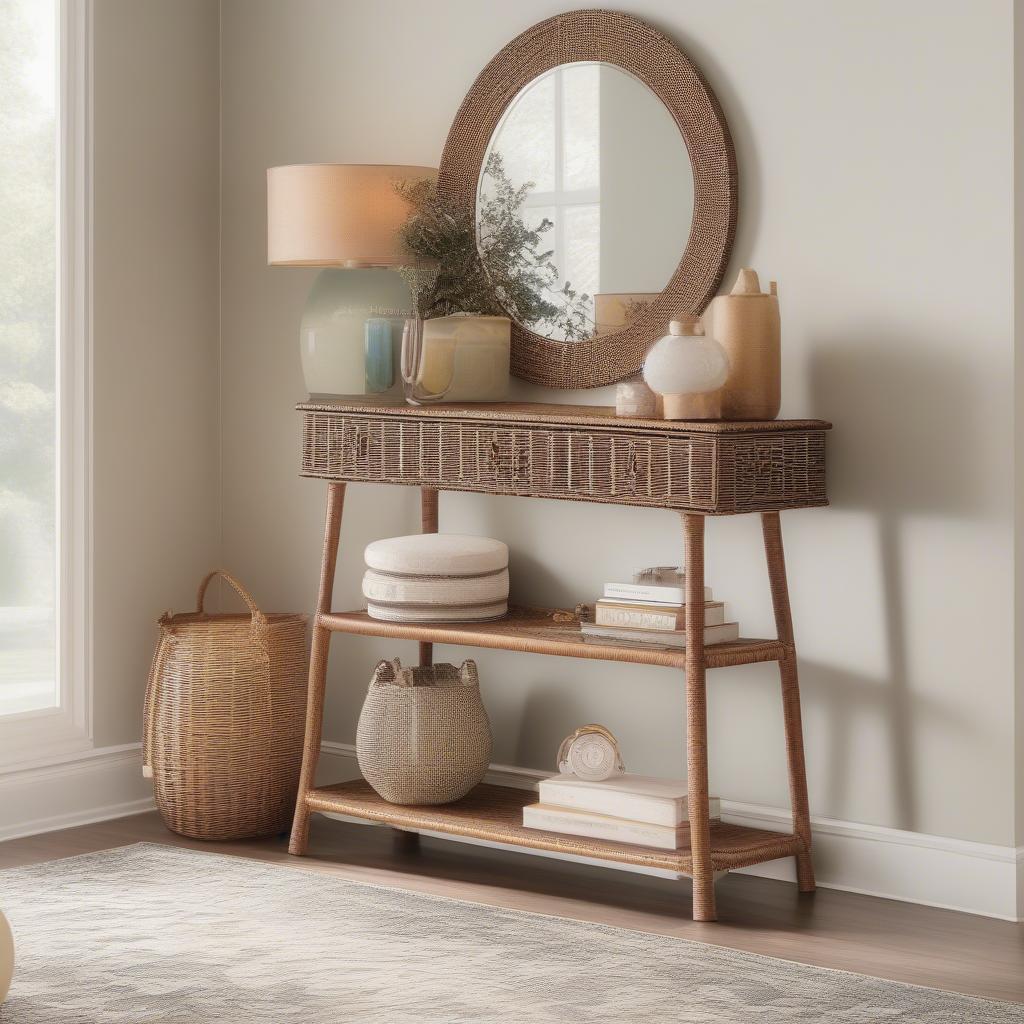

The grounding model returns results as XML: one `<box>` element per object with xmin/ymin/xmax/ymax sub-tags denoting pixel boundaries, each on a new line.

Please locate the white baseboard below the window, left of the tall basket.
<box><xmin>0</xmin><ymin>743</ymin><xmax>155</xmax><ymax>841</ymax></box>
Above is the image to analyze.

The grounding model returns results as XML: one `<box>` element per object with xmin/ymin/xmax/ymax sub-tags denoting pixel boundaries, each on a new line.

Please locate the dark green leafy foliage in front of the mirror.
<box><xmin>398</xmin><ymin>153</ymin><xmax>593</xmax><ymax>339</ymax></box>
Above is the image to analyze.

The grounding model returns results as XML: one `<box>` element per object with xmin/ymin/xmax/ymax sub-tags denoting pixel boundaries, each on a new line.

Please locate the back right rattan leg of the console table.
<box><xmin>761</xmin><ymin>512</ymin><xmax>814</xmax><ymax>893</ymax></box>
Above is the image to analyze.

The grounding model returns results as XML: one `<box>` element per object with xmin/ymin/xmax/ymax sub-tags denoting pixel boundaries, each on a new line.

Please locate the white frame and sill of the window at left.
<box><xmin>0</xmin><ymin>0</ymin><xmax>93</xmax><ymax>770</ymax></box>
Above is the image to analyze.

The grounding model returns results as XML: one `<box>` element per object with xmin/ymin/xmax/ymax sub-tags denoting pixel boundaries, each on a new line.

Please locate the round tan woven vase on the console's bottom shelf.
<box><xmin>355</xmin><ymin>658</ymin><xmax>490</xmax><ymax>804</ymax></box>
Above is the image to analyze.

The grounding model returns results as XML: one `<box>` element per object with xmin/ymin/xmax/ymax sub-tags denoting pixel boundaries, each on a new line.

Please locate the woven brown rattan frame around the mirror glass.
<box><xmin>438</xmin><ymin>10</ymin><xmax>737</xmax><ymax>388</ymax></box>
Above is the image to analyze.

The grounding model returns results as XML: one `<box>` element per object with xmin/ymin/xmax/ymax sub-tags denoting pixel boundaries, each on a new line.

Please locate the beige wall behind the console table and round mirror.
<box><xmin>214</xmin><ymin>0</ymin><xmax>1015</xmax><ymax>844</ymax></box>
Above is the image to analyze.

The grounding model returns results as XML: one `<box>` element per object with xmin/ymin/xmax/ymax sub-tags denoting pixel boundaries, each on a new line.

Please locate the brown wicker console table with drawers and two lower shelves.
<box><xmin>289</xmin><ymin>397</ymin><xmax>830</xmax><ymax>921</ymax></box>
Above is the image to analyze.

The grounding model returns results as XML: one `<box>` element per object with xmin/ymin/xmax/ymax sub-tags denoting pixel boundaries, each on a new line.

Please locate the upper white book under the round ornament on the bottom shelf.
<box><xmin>538</xmin><ymin>772</ymin><xmax>722</xmax><ymax>826</ymax></box>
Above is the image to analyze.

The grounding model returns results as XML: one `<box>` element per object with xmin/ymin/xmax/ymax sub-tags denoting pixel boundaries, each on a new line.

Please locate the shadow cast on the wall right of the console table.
<box><xmin>801</xmin><ymin>335</ymin><xmax>990</xmax><ymax>831</ymax></box>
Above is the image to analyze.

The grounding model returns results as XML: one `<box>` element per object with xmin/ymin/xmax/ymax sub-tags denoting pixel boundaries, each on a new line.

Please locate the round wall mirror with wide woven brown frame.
<box><xmin>437</xmin><ymin>10</ymin><xmax>737</xmax><ymax>388</ymax></box>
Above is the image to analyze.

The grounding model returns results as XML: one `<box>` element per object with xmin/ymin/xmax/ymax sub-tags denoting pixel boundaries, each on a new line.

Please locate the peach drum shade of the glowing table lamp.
<box><xmin>266</xmin><ymin>164</ymin><xmax>437</xmax><ymax>267</ymax></box>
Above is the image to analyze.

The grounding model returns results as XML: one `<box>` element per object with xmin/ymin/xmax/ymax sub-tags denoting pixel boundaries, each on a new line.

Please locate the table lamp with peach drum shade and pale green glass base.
<box><xmin>266</xmin><ymin>164</ymin><xmax>437</xmax><ymax>395</ymax></box>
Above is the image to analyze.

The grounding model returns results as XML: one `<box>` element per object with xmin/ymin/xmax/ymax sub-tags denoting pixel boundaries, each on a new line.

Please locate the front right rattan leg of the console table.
<box><xmin>683</xmin><ymin>513</ymin><xmax>717</xmax><ymax>921</ymax></box>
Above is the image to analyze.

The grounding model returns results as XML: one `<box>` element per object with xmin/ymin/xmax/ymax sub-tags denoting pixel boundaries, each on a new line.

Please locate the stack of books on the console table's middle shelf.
<box><xmin>581</xmin><ymin>567</ymin><xmax>739</xmax><ymax>648</ymax></box>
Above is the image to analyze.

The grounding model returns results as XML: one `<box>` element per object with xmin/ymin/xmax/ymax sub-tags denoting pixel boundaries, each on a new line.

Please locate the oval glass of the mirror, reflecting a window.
<box><xmin>476</xmin><ymin>61</ymin><xmax>693</xmax><ymax>341</ymax></box>
